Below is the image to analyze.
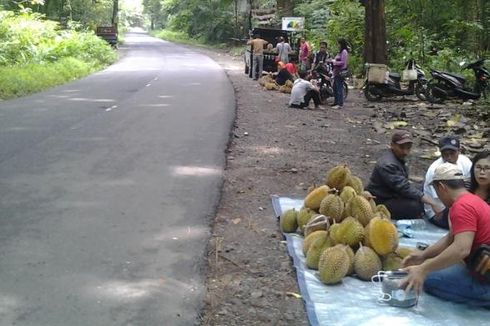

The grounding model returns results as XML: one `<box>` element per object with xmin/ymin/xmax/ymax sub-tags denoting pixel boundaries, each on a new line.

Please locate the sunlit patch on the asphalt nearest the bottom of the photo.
<box><xmin>95</xmin><ymin>279</ymin><xmax>163</xmax><ymax>300</ymax></box>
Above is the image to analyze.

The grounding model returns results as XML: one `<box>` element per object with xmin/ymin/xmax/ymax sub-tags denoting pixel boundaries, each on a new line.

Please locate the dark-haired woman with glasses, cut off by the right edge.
<box><xmin>470</xmin><ymin>151</ymin><xmax>490</xmax><ymax>205</ymax></box>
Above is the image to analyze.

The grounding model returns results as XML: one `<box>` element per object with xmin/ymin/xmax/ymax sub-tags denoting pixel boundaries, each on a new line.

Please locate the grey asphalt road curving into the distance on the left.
<box><xmin>0</xmin><ymin>33</ymin><xmax>235</xmax><ymax>326</ymax></box>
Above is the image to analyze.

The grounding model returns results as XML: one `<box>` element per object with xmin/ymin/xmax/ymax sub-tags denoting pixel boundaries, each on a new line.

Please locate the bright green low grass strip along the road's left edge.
<box><xmin>0</xmin><ymin>58</ymin><xmax>106</xmax><ymax>99</ymax></box>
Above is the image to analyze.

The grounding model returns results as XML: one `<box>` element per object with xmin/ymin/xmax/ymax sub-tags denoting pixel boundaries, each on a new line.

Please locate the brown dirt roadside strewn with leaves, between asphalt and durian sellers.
<box><xmin>194</xmin><ymin>50</ymin><xmax>490</xmax><ymax>325</ymax></box>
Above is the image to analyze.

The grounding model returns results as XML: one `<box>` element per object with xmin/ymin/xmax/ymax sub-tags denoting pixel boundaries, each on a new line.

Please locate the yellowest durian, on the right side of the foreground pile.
<box><xmin>366</xmin><ymin>216</ymin><xmax>398</xmax><ymax>256</ymax></box>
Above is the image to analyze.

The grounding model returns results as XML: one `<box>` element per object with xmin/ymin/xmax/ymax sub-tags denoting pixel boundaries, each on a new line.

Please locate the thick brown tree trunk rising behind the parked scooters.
<box><xmin>364</xmin><ymin>0</ymin><xmax>387</xmax><ymax>64</ymax></box>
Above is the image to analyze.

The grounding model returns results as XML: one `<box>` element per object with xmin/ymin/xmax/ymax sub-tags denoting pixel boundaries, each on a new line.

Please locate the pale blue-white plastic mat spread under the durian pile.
<box><xmin>272</xmin><ymin>195</ymin><xmax>490</xmax><ymax>326</ymax></box>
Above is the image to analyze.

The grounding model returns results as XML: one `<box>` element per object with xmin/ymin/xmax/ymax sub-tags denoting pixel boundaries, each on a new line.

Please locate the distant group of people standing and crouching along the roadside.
<box><xmin>247</xmin><ymin>35</ymin><xmax>349</xmax><ymax>109</ymax></box>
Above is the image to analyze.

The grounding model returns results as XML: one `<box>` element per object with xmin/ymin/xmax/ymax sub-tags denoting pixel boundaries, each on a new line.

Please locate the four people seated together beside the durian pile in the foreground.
<box><xmin>366</xmin><ymin>129</ymin><xmax>490</xmax><ymax>308</ymax></box>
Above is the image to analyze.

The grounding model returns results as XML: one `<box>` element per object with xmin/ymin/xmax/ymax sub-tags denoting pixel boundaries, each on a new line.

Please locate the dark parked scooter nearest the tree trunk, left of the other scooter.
<box><xmin>363</xmin><ymin>59</ymin><xmax>427</xmax><ymax>101</ymax></box>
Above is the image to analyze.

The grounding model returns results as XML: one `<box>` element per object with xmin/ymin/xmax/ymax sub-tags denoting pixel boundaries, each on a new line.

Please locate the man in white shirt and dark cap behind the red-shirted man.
<box><xmin>424</xmin><ymin>136</ymin><xmax>471</xmax><ymax>229</ymax></box>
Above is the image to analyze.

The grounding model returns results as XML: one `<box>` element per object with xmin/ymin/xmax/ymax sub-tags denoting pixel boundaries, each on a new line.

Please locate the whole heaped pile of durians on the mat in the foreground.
<box><xmin>280</xmin><ymin>165</ymin><xmax>414</xmax><ymax>284</ymax></box>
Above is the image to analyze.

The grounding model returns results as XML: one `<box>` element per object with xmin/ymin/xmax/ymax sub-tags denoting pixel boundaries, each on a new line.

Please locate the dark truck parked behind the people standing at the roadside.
<box><xmin>244</xmin><ymin>28</ymin><xmax>298</xmax><ymax>77</ymax></box>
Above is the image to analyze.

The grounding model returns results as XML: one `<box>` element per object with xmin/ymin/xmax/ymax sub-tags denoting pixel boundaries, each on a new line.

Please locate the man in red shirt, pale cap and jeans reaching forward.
<box><xmin>402</xmin><ymin>163</ymin><xmax>490</xmax><ymax>307</ymax></box>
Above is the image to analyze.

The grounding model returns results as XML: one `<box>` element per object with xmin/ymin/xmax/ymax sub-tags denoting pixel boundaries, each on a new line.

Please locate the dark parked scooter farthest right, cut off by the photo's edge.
<box><xmin>426</xmin><ymin>59</ymin><xmax>490</xmax><ymax>103</ymax></box>
